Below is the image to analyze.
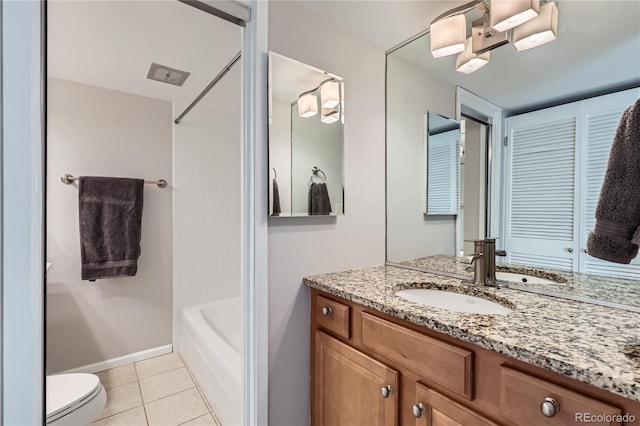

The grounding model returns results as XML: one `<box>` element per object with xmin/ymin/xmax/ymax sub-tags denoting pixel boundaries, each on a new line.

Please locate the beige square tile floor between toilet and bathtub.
<box><xmin>92</xmin><ymin>352</ymin><xmax>221</xmax><ymax>426</ymax></box>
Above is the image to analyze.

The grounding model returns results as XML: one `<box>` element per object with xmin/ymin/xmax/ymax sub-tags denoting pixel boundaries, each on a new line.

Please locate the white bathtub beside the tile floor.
<box><xmin>181</xmin><ymin>297</ymin><xmax>242</xmax><ymax>426</ymax></box>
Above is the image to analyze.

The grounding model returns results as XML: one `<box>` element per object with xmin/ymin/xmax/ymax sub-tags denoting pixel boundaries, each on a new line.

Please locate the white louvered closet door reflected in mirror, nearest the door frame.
<box><xmin>504</xmin><ymin>104</ymin><xmax>579</xmax><ymax>270</ymax></box>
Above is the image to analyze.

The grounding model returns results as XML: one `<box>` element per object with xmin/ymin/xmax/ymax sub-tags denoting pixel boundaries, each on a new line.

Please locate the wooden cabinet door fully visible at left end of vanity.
<box><xmin>312</xmin><ymin>331</ymin><xmax>398</xmax><ymax>426</ymax></box>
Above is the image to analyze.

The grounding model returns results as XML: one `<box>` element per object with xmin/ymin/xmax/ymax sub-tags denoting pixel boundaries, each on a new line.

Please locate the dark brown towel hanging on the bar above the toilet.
<box><xmin>78</xmin><ymin>176</ymin><xmax>144</xmax><ymax>281</ymax></box>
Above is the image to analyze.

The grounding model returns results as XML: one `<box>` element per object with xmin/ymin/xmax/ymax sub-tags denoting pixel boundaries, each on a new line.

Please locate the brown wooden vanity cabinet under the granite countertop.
<box><xmin>311</xmin><ymin>289</ymin><xmax>640</xmax><ymax>426</ymax></box>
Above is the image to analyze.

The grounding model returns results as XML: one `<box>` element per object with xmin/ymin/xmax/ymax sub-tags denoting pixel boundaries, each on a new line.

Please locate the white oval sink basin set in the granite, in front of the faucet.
<box><xmin>396</xmin><ymin>288</ymin><xmax>511</xmax><ymax>315</ymax></box>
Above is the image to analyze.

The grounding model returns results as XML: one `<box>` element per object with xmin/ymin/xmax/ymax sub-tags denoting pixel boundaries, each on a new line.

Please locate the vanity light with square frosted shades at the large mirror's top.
<box><xmin>430</xmin><ymin>0</ymin><xmax>558</xmax><ymax>74</ymax></box>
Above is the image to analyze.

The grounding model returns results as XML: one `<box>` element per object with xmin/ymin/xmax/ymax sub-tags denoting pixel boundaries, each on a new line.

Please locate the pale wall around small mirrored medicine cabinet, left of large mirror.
<box><xmin>264</xmin><ymin>1</ymin><xmax>385</xmax><ymax>426</ymax></box>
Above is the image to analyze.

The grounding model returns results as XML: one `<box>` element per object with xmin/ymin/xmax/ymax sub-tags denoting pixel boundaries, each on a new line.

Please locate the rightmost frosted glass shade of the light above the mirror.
<box><xmin>511</xmin><ymin>2</ymin><xmax>558</xmax><ymax>52</ymax></box>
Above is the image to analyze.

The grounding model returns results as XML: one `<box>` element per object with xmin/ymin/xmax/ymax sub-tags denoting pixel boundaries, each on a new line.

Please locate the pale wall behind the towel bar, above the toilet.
<box><xmin>47</xmin><ymin>78</ymin><xmax>172</xmax><ymax>373</ymax></box>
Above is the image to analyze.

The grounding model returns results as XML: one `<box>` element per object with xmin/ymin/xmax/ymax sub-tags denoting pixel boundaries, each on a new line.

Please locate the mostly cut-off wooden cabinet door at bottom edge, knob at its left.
<box><xmin>413</xmin><ymin>383</ymin><xmax>498</xmax><ymax>426</ymax></box>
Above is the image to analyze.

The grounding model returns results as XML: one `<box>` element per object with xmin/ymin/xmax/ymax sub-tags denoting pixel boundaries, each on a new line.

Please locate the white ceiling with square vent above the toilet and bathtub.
<box><xmin>47</xmin><ymin>0</ymin><xmax>241</xmax><ymax>115</ymax></box>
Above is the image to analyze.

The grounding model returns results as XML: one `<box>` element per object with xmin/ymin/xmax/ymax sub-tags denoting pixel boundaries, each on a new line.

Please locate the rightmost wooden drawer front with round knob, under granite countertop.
<box><xmin>500</xmin><ymin>366</ymin><xmax>622</xmax><ymax>426</ymax></box>
